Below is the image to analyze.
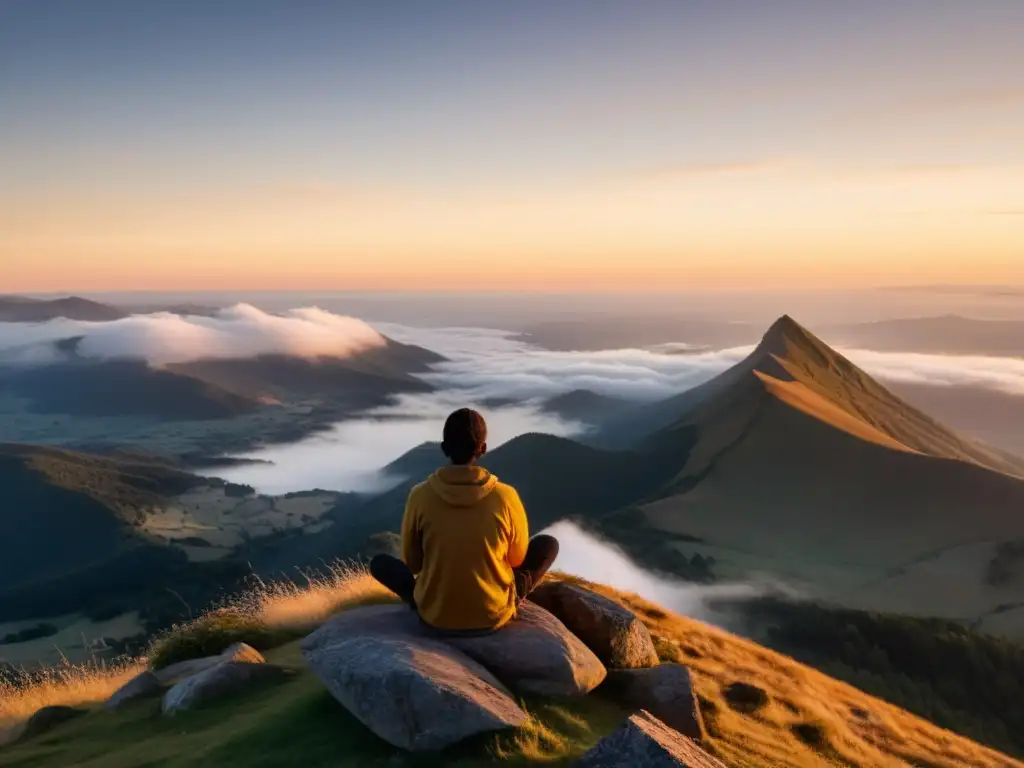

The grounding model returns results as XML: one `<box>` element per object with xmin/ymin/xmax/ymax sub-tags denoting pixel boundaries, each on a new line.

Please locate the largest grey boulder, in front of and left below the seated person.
<box><xmin>302</xmin><ymin>605</ymin><xmax>528</xmax><ymax>752</ymax></box>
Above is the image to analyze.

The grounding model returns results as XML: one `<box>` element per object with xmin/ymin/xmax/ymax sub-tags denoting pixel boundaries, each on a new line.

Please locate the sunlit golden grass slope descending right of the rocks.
<box><xmin>573</xmin><ymin>580</ymin><xmax>1024</xmax><ymax>768</ymax></box>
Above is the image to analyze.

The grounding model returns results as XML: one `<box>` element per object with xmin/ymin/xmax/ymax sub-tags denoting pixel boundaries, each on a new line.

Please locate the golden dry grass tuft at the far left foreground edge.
<box><xmin>0</xmin><ymin>658</ymin><xmax>145</xmax><ymax>744</ymax></box>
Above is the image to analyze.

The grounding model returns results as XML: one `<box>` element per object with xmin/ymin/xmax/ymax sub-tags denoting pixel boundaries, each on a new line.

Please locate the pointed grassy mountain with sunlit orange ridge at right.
<box><xmin>600</xmin><ymin>317</ymin><xmax>1024</xmax><ymax>634</ymax></box>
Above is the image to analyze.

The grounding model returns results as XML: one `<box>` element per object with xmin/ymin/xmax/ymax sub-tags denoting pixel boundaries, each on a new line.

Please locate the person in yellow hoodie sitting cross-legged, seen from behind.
<box><xmin>370</xmin><ymin>408</ymin><xmax>558</xmax><ymax>635</ymax></box>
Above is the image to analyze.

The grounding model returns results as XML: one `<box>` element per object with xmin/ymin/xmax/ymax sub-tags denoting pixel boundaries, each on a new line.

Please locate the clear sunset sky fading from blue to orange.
<box><xmin>0</xmin><ymin>0</ymin><xmax>1024</xmax><ymax>292</ymax></box>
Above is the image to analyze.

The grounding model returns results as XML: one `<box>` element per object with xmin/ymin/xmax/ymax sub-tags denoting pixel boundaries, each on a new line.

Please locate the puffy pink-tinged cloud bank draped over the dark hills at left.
<box><xmin>0</xmin><ymin>304</ymin><xmax>384</xmax><ymax>365</ymax></box>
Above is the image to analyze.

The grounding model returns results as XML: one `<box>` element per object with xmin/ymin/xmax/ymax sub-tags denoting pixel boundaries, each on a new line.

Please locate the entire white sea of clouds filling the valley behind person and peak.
<box><xmin>6</xmin><ymin>304</ymin><xmax>1024</xmax><ymax>494</ymax></box>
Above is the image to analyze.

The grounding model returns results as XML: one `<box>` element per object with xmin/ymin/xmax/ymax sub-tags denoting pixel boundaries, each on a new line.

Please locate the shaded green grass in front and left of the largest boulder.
<box><xmin>0</xmin><ymin>641</ymin><xmax>624</xmax><ymax>768</ymax></box>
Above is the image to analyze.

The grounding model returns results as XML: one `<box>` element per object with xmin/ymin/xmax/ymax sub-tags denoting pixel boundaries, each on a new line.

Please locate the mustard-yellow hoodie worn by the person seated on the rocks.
<box><xmin>401</xmin><ymin>466</ymin><xmax>529</xmax><ymax>630</ymax></box>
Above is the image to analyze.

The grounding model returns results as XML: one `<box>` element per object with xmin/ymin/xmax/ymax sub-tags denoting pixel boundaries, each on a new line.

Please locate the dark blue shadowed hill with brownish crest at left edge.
<box><xmin>0</xmin><ymin>444</ymin><xmax>196</xmax><ymax>621</ymax></box>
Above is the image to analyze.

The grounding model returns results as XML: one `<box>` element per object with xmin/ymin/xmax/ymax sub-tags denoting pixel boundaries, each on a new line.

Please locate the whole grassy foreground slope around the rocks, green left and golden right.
<box><xmin>0</xmin><ymin>586</ymin><xmax>1022</xmax><ymax>768</ymax></box>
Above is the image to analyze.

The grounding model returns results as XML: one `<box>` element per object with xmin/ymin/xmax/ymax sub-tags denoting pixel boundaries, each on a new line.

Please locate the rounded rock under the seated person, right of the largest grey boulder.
<box><xmin>444</xmin><ymin>602</ymin><xmax>606</xmax><ymax>696</ymax></box>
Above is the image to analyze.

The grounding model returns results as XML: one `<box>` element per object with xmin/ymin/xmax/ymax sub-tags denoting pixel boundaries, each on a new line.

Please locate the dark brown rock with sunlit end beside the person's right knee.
<box><xmin>529</xmin><ymin>582</ymin><xmax>657</xmax><ymax>670</ymax></box>
